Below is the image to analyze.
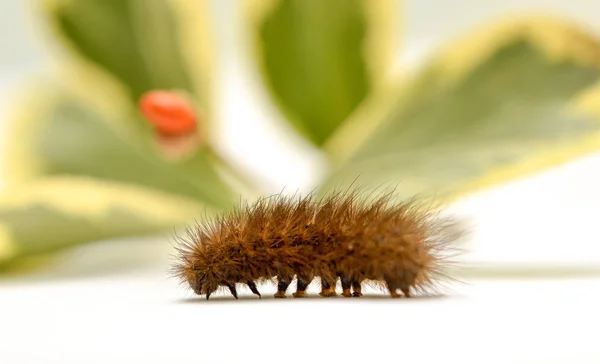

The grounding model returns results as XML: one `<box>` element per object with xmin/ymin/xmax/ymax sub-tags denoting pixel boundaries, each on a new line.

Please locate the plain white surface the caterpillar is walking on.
<box><xmin>0</xmin><ymin>273</ymin><xmax>600</xmax><ymax>364</ymax></box>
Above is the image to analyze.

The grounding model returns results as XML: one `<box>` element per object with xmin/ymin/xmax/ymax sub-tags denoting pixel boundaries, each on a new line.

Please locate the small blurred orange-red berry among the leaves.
<box><xmin>140</xmin><ymin>91</ymin><xmax>196</xmax><ymax>135</ymax></box>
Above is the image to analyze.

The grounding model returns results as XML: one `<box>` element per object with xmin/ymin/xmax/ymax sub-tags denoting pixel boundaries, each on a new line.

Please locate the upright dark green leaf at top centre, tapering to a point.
<box><xmin>247</xmin><ymin>0</ymin><xmax>397</xmax><ymax>145</ymax></box>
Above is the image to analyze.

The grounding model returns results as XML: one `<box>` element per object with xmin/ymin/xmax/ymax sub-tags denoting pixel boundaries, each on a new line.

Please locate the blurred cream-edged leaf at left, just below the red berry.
<box><xmin>3</xmin><ymin>88</ymin><xmax>237</xmax><ymax>208</ymax></box>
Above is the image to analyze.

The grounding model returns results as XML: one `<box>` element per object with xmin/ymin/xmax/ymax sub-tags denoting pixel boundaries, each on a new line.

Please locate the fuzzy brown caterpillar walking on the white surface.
<box><xmin>173</xmin><ymin>189</ymin><xmax>460</xmax><ymax>299</ymax></box>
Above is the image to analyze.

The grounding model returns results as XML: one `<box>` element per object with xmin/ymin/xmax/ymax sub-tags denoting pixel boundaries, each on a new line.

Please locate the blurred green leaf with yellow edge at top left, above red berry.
<box><xmin>39</xmin><ymin>0</ymin><xmax>212</xmax><ymax>108</ymax></box>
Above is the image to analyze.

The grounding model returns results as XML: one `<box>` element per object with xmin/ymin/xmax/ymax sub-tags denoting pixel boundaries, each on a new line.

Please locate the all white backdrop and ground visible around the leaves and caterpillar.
<box><xmin>0</xmin><ymin>0</ymin><xmax>600</xmax><ymax>363</ymax></box>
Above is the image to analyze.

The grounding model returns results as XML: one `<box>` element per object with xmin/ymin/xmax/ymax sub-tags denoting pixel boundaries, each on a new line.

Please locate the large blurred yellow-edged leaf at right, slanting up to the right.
<box><xmin>323</xmin><ymin>17</ymin><xmax>600</xmax><ymax>201</ymax></box>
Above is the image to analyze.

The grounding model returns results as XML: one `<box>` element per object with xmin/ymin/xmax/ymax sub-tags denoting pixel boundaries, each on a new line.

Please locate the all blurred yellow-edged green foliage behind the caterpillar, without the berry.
<box><xmin>0</xmin><ymin>0</ymin><xmax>600</xmax><ymax>266</ymax></box>
